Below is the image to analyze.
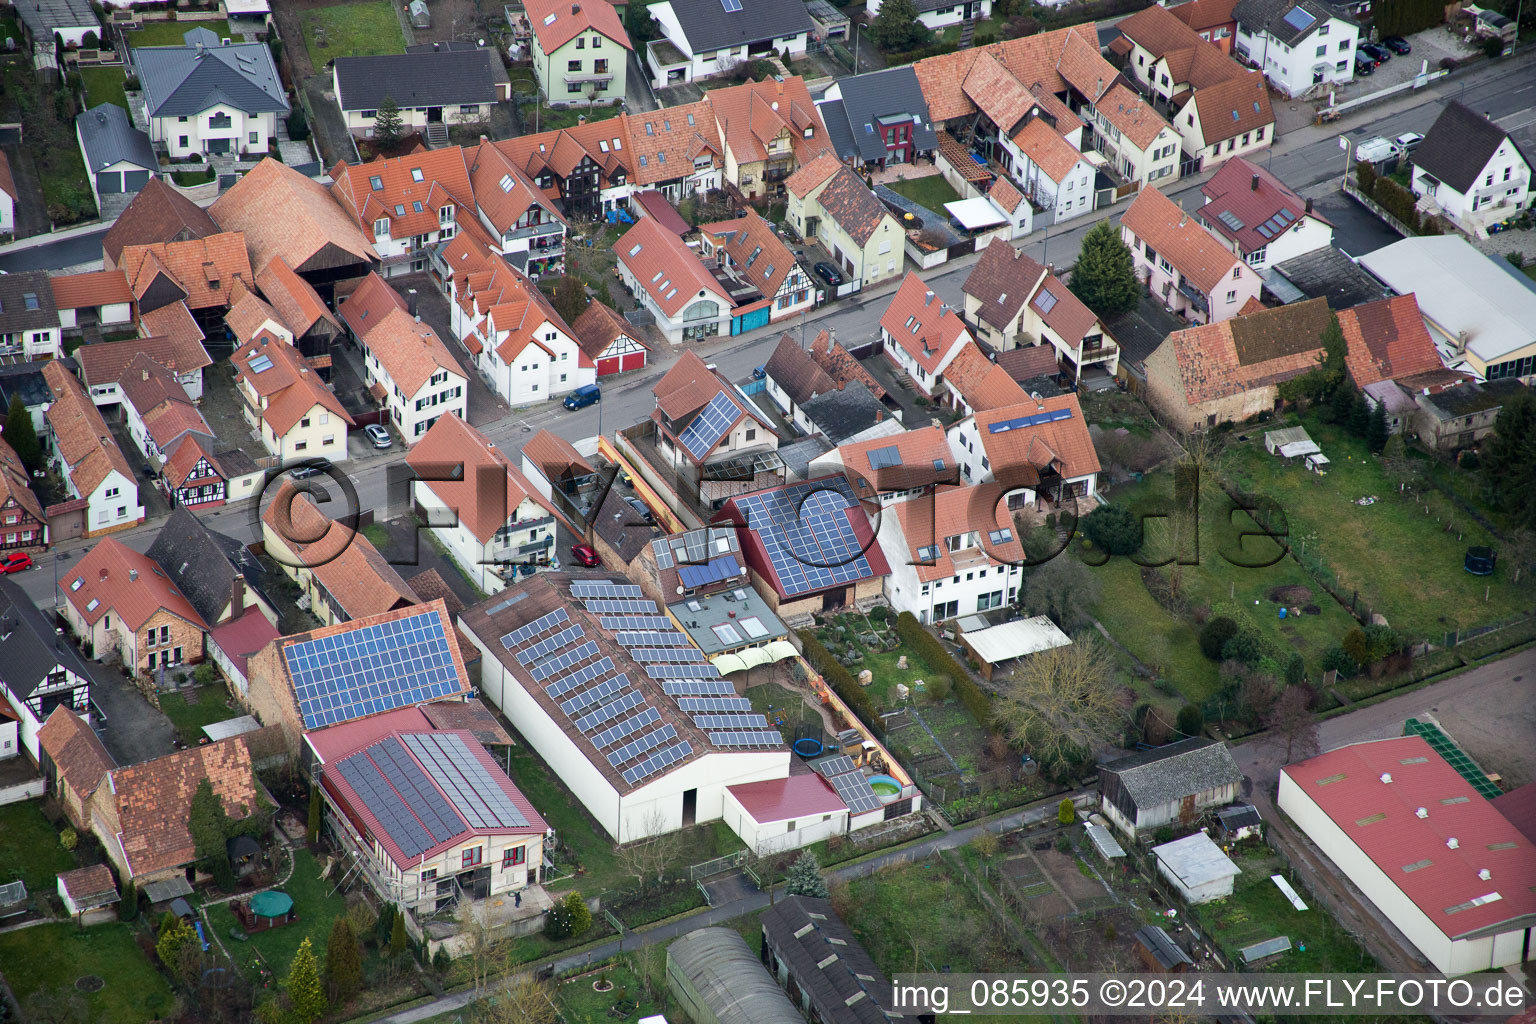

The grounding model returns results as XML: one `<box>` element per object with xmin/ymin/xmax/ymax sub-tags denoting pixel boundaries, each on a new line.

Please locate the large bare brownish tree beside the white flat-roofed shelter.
<box><xmin>997</xmin><ymin>634</ymin><xmax>1126</xmax><ymax>761</ymax></box>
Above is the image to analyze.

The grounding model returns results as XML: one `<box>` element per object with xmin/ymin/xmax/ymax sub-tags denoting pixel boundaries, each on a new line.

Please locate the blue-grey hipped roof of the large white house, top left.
<box><xmin>132</xmin><ymin>29</ymin><xmax>289</xmax><ymax>117</ymax></box>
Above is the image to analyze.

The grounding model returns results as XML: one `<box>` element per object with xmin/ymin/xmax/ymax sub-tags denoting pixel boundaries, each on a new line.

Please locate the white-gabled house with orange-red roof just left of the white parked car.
<box><xmin>230</xmin><ymin>332</ymin><xmax>355</xmax><ymax>465</ymax></box>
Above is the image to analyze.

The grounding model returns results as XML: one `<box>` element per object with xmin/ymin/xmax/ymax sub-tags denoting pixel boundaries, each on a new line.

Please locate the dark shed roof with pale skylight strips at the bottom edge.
<box><xmin>762</xmin><ymin>897</ymin><xmax>892</xmax><ymax>1024</ymax></box>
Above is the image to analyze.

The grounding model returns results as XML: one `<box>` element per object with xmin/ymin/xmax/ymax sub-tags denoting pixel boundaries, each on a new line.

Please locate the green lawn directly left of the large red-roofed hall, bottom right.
<box><xmin>1195</xmin><ymin>854</ymin><xmax>1376</xmax><ymax>973</ymax></box>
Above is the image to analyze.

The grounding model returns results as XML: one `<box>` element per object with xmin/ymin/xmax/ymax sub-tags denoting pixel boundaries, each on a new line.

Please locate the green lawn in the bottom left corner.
<box><xmin>0</xmin><ymin>921</ymin><xmax>170</xmax><ymax>1024</ymax></box>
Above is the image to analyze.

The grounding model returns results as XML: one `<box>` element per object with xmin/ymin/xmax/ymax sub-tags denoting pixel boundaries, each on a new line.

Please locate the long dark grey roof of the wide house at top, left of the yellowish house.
<box><xmin>336</xmin><ymin>49</ymin><xmax>496</xmax><ymax>111</ymax></box>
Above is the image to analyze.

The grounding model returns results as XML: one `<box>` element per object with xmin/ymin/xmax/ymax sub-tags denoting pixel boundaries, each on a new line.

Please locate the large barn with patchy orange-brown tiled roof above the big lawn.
<box><xmin>1146</xmin><ymin>299</ymin><xmax>1332</xmax><ymax>431</ymax></box>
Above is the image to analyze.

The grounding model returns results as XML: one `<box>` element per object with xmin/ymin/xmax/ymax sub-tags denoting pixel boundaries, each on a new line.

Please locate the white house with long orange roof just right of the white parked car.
<box><xmin>338</xmin><ymin>273</ymin><xmax>468</xmax><ymax>444</ymax></box>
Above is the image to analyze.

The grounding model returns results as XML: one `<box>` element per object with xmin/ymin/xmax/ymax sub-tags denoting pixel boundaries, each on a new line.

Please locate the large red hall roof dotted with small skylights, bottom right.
<box><xmin>1281</xmin><ymin>735</ymin><xmax>1536</xmax><ymax>940</ymax></box>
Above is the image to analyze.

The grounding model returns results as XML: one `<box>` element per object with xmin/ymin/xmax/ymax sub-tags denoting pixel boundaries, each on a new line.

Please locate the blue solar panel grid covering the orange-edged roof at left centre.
<box><xmin>283</xmin><ymin>611</ymin><xmax>462</xmax><ymax>729</ymax></box>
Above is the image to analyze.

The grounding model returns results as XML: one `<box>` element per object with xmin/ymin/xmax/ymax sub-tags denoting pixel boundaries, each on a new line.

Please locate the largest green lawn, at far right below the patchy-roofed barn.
<box><xmin>1229</xmin><ymin>418</ymin><xmax>1527</xmax><ymax>642</ymax></box>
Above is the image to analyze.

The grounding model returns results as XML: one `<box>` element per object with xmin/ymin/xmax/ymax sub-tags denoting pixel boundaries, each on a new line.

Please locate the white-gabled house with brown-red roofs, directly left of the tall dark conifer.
<box><xmin>963</xmin><ymin>238</ymin><xmax>1120</xmax><ymax>381</ymax></box>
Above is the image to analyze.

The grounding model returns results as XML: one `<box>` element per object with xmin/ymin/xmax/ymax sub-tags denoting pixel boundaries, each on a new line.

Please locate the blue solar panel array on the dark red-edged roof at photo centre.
<box><xmin>736</xmin><ymin>477</ymin><xmax>874</xmax><ymax>597</ymax></box>
